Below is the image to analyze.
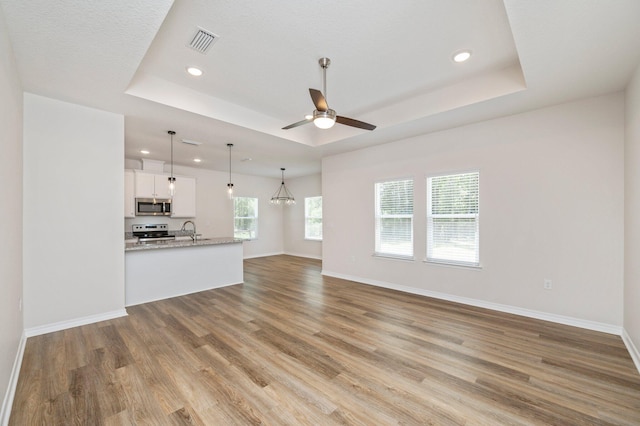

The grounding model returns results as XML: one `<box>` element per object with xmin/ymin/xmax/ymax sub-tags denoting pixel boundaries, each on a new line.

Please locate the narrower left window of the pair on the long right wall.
<box><xmin>375</xmin><ymin>179</ymin><xmax>413</xmax><ymax>258</ymax></box>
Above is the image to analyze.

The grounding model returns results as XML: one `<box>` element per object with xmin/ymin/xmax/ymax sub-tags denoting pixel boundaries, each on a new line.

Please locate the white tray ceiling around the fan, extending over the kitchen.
<box><xmin>0</xmin><ymin>0</ymin><xmax>640</xmax><ymax>177</ymax></box>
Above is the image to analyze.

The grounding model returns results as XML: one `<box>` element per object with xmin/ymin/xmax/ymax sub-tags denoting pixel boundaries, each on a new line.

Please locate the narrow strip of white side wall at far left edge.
<box><xmin>0</xmin><ymin>7</ymin><xmax>23</xmax><ymax>424</ymax></box>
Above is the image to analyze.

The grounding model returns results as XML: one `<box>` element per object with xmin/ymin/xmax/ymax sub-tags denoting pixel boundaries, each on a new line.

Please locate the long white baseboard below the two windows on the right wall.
<box><xmin>322</xmin><ymin>270</ymin><xmax>622</xmax><ymax>336</ymax></box>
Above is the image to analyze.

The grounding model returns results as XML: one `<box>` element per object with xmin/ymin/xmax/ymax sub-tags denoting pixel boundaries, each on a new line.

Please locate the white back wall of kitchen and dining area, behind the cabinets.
<box><xmin>124</xmin><ymin>159</ymin><xmax>284</xmax><ymax>258</ymax></box>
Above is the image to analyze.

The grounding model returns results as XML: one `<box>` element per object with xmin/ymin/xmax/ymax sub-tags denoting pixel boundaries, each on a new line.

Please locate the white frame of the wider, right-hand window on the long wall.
<box><xmin>425</xmin><ymin>169</ymin><xmax>481</xmax><ymax>268</ymax></box>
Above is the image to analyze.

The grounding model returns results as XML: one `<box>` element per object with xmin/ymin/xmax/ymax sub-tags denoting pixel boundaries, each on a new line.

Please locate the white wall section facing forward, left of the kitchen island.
<box><xmin>23</xmin><ymin>93</ymin><xmax>124</xmax><ymax>330</ymax></box>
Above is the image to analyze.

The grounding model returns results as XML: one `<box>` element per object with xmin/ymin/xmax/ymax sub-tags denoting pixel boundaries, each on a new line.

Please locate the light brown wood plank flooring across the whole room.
<box><xmin>10</xmin><ymin>256</ymin><xmax>640</xmax><ymax>425</ymax></box>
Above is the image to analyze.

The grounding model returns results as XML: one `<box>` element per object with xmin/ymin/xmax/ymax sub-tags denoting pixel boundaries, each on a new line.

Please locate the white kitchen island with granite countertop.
<box><xmin>125</xmin><ymin>237</ymin><xmax>243</xmax><ymax>306</ymax></box>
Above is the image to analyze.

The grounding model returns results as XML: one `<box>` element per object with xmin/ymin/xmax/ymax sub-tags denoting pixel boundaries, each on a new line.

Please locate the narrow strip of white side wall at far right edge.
<box><xmin>624</xmin><ymin>62</ymin><xmax>640</xmax><ymax>362</ymax></box>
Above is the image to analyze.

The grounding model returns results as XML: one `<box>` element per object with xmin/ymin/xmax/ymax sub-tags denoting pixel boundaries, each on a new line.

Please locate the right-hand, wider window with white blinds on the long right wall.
<box><xmin>427</xmin><ymin>172</ymin><xmax>480</xmax><ymax>266</ymax></box>
